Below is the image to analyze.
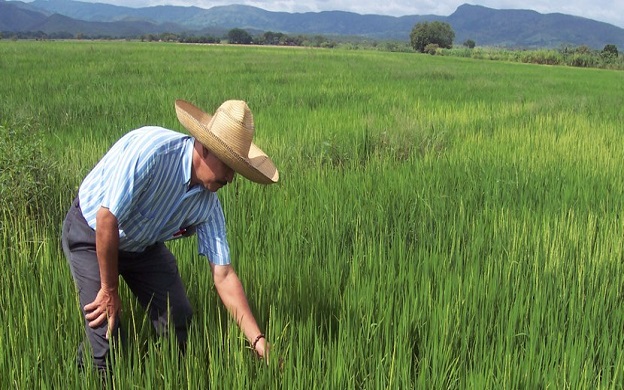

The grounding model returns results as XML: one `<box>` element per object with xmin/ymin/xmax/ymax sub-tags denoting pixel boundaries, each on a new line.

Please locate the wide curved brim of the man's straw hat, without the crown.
<box><xmin>175</xmin><ymin>100</ymin><xmax>279</xmax><ymax>184</ymax></box>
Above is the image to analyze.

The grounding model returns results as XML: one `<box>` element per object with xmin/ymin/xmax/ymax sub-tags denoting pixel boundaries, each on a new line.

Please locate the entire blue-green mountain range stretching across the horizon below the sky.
<box><xmin>0</xmin><ymin>0</ymin><xmax>624</xmax><ymax>49</ymax></box>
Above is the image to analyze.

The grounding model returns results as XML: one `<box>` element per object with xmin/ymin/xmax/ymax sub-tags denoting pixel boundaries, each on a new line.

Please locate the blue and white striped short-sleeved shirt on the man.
<box><xmin>78</xmin><ymin>126</ymin><xmax>230</xmax><ymax>265</ymax></box>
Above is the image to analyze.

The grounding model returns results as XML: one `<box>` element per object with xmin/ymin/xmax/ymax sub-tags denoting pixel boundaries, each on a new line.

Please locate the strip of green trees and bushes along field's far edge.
<box><xmin>0</xmin><ymin>21</ymin><xmax>624</xmax><ymax>69</ymax></box>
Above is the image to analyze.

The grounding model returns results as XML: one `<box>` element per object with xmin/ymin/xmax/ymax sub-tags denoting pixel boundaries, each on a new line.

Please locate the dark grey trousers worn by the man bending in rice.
<box><xmin>62</xmin><ymin>199</ymin><xmax>193</xmax><ymax>370</ymax></box>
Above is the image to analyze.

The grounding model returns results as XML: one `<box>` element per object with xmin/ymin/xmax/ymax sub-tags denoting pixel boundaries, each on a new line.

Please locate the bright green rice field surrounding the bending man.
<box><xmin>0</xmin><ymin>41</ymin><xmax>624</xmax><ymax>389</ymax></box>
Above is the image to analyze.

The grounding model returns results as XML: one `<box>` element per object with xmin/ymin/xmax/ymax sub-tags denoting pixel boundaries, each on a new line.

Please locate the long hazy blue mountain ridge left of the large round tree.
<box><xmin>16</xmin><ymin>0</ymin><xmax>444</xmax><ymax>40</ymax></box>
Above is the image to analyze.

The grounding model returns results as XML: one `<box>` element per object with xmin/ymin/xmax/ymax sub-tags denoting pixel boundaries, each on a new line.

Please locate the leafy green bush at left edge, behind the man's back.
<box><xmin>0</xmin><ymin>117</ymin><xmax>59</xmax><ymax>219</ymax></box>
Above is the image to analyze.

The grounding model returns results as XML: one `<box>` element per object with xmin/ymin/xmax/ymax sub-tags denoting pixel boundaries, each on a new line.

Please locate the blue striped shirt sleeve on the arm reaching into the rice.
<box><xmin>197</xmin><ymin>198</ymin><xmax>230</xmax><ymax>265</ymax></box>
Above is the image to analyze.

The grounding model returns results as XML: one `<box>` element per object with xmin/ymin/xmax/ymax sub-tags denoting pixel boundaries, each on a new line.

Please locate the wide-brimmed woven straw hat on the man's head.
<box><xmin>175</xmin><ymin>100</ymin><xmax>279</xmax><ymax>184</ymax></box>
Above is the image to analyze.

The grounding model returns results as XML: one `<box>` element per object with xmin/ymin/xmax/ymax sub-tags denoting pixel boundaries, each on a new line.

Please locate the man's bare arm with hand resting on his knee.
<box><xmin>84</xmin><ymin>207</ymin><xmax>121</xmax><ymax>337</ymax></box>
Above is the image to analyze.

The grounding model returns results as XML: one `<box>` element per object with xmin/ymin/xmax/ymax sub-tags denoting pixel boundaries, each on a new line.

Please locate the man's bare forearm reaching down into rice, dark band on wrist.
<box><xmin>210</xmin><ymin>263</ymin><xmax>267</xmax><ymax>358</ymax></box>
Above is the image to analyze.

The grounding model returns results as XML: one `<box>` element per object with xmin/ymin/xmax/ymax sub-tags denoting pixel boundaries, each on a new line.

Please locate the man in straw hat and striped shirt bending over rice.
<box><xmin>62</xmin><ymin>100</ymin><xmax>279</xmax><ymax>370</ymax></box>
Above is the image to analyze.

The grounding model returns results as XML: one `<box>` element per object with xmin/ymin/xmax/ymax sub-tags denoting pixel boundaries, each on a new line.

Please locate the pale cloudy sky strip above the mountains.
<box><xmin>35</xmin><ymin>0</ymin><xmax>624</xmax><ymax>28</ymax></box>
